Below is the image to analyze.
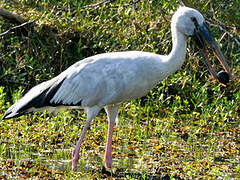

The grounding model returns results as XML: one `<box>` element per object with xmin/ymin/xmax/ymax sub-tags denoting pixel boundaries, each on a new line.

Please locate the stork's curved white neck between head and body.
<box><xmin>166</xmin><ymin>28</ymin><xmax>187</xmax><ymax>73</ymax></box>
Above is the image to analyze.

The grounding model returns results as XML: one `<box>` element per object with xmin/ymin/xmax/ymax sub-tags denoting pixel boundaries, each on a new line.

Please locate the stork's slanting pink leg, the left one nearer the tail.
<box><xmin>72</xmin><ymin>106</ymin><xmax>101</xmax><ymax>172</ymax></box>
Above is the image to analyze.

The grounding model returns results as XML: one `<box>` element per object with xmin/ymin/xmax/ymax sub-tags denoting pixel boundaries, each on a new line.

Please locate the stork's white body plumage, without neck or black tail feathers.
<box><xmin>50</xmin><ymin>51</ymin><xmax>180</xmax><ymax>107</ymax></box>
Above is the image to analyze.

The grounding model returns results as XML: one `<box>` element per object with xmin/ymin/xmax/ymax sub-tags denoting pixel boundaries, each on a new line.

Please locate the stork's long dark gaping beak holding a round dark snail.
<box><xmin>192</xmin><ymin>22</ymin><xmax>232</xmax><ymax>85</ymax></box>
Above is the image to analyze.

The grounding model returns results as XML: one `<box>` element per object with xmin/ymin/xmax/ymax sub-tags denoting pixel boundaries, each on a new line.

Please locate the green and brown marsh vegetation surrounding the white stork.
<box><xmin>0</xmin><ymin>0</ymin><xmax>240</xmax><ymax>179</ymax></box>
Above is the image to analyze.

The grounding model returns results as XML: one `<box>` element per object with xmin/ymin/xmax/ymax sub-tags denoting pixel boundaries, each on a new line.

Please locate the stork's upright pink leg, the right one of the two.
<box><xmin>105</xmin><ymin>105</ymin><xmax>119</xmax><ymax>168</ymax></box>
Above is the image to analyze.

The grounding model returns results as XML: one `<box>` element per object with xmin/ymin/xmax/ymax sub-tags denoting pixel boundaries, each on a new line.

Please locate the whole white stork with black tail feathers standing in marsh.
<box><xmin>3</xmin><ymin>7</ymin><xmax>231</xmax><ymax>171</ymax></box>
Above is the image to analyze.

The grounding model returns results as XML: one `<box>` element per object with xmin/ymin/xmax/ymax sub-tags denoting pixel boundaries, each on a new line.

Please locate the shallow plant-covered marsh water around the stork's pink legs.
<box><xmin>0</xmin><ymin>113</ymin><xmax>240</xmax><ymax>179</ymax></box>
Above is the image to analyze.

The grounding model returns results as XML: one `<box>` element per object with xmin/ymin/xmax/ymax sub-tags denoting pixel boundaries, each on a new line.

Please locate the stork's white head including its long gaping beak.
<box><xmin>171</xmin><ymin>7</ymin><xmax>232</xmax><ymax>85</ymax></box>
